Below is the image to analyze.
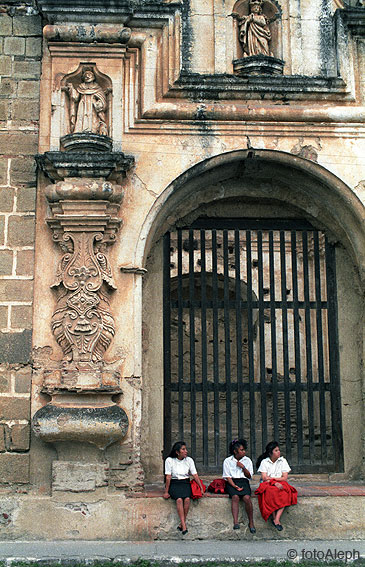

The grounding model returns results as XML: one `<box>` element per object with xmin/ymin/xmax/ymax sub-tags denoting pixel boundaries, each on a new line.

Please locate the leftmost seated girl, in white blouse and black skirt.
<box><xmin>163</xmin><ymin>441</ymin><xmax>204</xmax><ymax>535</ymax></box>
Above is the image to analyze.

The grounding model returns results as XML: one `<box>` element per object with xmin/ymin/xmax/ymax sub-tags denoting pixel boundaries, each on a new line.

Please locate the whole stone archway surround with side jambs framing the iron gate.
<box><xmin>139</xmin><ymin>149</ymin><xmax>365</xmax><ymax>479</ymax></box>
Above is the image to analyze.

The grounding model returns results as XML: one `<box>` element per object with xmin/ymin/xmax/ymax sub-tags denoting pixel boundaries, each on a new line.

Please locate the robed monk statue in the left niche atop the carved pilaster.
<box><xmin>66</xmin><ymin>67</ymin><xmax>108</xmax><ymax>136</ymax></box>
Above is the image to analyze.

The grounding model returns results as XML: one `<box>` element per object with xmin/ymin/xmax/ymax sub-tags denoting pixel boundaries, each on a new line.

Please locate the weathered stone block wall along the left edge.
<box><xmin>0</xmin><ymin>2</ymin><xmax>42</xmax><ymax>484</ymax></box>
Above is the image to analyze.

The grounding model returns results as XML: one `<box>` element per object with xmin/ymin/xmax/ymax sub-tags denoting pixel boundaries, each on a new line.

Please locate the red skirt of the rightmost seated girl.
<box><xmin>255</xmin><ymin>480</ymin><xmax>298</xmax><ymax>522</ymax></box>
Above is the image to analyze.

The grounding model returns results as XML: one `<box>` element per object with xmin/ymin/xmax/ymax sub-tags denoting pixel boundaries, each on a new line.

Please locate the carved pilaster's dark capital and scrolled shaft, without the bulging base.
<box><xmin>37</xmin><ymin>144</ymin><xmax>134</xmax><ymax>390</ymax></box>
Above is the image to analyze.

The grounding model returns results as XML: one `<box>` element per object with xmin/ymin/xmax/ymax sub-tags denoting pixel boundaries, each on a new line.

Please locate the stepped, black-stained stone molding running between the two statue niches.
<box><xmin>39</xmin><ymin>0</ymin><xmax>354</xmax><ymax>131</ymax></box>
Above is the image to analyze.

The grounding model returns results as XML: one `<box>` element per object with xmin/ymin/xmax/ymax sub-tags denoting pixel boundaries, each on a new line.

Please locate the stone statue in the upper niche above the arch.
<box><xmin>238</xmin><ymin>0</ymin><xmax>272</xmax><ymax>57</ymax></box>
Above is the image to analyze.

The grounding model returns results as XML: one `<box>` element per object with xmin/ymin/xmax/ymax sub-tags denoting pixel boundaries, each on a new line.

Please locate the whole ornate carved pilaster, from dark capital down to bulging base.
<box><xmin>33</xmin><ymin>144</ymin><xmax>133</xmax><ymax>492</ymax></box>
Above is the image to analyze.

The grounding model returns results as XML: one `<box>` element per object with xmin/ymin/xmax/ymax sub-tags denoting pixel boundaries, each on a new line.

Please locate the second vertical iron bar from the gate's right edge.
<box><xmin>314</xmin><ymin>230</ymin><xmax>327</xmax><ymax>463</ymax></box>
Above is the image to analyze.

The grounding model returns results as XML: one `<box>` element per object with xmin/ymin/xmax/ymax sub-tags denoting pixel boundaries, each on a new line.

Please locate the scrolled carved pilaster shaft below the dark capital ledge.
<box><xmin>47</xmin><ymin>179</ymin><xmax>120</xmax><ymax>388</ymax></box>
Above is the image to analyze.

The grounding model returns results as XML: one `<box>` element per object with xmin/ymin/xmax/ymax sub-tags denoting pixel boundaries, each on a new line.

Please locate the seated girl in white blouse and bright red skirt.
<box><xmin>255</xmin><ymin>441</ymin><xmax>297</xmax><ymax>532</ymax></box>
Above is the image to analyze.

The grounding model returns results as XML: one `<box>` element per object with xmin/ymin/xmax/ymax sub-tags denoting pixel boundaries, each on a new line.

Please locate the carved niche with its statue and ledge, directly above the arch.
<box><xmin>232</xmin><ymin>0</ymin><xmax>284</xmax><ymax>76</ymax></box>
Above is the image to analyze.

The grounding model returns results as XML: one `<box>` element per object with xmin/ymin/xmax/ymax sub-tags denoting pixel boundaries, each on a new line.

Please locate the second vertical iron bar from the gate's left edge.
<box><xmin>177</xmin><ymin>228</ymin><xmax>184</xmax><ymax>439</ymax></box>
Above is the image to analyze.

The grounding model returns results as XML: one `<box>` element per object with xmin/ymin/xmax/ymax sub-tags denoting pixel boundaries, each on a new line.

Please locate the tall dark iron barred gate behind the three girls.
<box><xmin>163</xmin><ymin>218</ymin><xmax>343</xmax><ymax>473</ymax></box>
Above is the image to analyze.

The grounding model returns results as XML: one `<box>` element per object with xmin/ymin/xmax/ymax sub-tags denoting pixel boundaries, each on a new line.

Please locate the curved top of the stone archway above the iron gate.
<box><xmin>136</xmin><ymin>149</ymin><xmax>365</xmax><ymax>282</ymax></box>
